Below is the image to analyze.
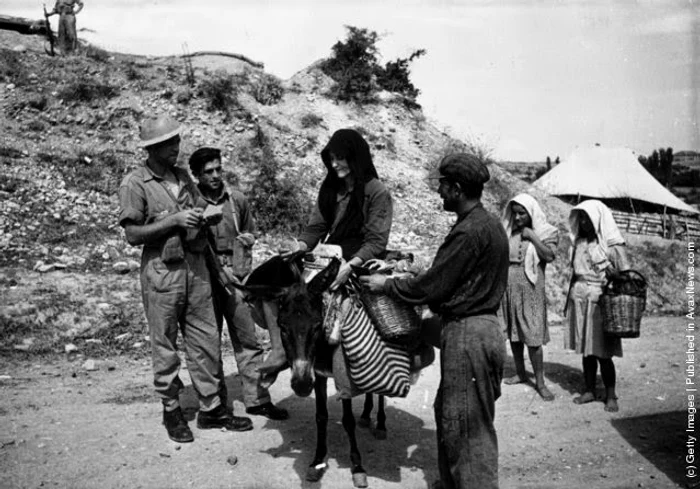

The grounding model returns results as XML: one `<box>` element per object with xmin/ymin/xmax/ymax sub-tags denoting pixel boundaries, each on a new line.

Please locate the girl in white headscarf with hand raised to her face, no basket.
<box><xmin>501</xmin><ymin>194</ymin><xmax>559</xmax><ymax>401</ymax></box>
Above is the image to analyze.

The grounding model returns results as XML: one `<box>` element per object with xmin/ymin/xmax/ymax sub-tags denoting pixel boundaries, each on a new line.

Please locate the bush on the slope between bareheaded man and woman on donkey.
<box><xmin>250</xmin><ymin>127</ymin><xmax>308</xmax><ymax>234</ymax></box>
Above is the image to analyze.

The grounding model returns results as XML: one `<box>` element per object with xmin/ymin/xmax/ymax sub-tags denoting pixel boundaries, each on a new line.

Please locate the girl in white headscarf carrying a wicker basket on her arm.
<box><xmin>564</xmin><ymin>200</ymin><xmax>630</xmax><ymax>412</ymax></box>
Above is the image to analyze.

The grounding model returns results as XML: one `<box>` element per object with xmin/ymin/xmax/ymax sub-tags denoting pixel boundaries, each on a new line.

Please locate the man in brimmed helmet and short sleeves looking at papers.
<box><xmin>119</xmin><ymin>116</ymin><xmax>253</xmax><ymax>443</ymax></box>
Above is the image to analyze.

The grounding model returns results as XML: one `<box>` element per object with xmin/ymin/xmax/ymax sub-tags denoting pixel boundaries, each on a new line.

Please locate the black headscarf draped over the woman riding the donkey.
<box><xmin>318</xmin><ymin>129</ymin><xmax>379</xmax><ymax>255</ymax></box>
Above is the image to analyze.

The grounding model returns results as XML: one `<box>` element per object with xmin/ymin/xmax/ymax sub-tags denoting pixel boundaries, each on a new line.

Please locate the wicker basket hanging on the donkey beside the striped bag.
<box><xmin>360</xmin><ymin>291</ymin><xmax>420</xmax><ymax>348</ymax></box>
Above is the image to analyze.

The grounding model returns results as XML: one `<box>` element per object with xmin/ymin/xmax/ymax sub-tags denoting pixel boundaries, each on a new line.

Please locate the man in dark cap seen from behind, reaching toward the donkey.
<box><xmin>361</xmin><ymin>153</ymin><xmax>508</xmax><ymax>489</ymax></box>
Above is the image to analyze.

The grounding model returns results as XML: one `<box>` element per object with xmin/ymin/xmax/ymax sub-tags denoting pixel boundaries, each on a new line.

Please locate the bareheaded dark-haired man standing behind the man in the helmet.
<box><xmin>189</xmin><ymin>148</ymin><xmax>289</xmax><ymax>420</ymax></box>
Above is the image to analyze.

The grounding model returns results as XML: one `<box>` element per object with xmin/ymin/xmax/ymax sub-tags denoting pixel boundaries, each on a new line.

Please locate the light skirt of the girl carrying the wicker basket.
<box><xmin>564</xmin><ymin>280</ymin><xmax>622</xmax><ymax>358</ymax></box>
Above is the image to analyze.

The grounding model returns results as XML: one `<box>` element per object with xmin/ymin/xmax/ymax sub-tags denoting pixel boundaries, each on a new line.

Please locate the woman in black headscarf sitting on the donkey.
<box><xmin>266</xmin><ymin>129</ymin><xmax>393</xmax><ymax>376</ymax></box>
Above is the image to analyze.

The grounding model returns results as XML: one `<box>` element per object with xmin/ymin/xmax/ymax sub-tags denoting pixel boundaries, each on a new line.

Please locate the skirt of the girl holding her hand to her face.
<box><xmin>501</xmin><ymin>263</ymin><xmax>549</xmax><ymax>347</ymax></box>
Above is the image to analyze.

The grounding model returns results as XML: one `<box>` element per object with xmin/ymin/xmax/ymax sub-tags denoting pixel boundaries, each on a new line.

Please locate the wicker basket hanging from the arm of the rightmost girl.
<box><xmin>600</xmin><ymin>270</ymin><xmax>647</xmax><ymax>338</ymax></box>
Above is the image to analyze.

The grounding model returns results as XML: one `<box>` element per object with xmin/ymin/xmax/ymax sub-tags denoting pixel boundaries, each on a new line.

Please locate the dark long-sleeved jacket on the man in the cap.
<box><xmin>384</xmin><ymin>204</ymin><xmax>509</xmax><ymax>321</ymax></box>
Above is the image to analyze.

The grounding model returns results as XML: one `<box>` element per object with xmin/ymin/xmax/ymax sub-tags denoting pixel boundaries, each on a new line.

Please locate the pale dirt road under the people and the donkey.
<box><xmin>0</xmin><ymin>317</ymin><xmax>687</xmax><ymax>489</ymax></box>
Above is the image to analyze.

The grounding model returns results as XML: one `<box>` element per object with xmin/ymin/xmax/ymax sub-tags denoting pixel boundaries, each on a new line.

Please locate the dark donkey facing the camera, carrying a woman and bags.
<box><xmin>242</xmin><ymin>254</ymin><xmax>386</xmax><ymax>487</ymax></box>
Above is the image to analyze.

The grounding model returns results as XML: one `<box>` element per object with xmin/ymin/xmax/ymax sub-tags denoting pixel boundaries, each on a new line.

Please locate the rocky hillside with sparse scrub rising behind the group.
<box><xmin>0</xmin><ymin>31</ymin><xmax>682</xmax><ymax>358</ymax></box>
